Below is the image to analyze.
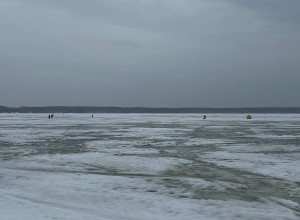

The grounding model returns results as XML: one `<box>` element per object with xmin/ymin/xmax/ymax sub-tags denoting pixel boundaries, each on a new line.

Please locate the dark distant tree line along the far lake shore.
<box><xmin>0</xmin><ymin>106</ymin><xmax>300</xmax><ymax>113</ymax></box>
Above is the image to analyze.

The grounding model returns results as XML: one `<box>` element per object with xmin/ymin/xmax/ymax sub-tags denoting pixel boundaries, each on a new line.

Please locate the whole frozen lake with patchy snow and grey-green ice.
<box><xmin>0</xmin><ymin>114</ymin><xmax>300</xmax><ymax>220</ymax></box>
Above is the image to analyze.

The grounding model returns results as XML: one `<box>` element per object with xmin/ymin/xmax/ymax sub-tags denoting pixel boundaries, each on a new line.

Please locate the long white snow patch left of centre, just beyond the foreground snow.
<box><xmin>10</xmin><ymin>150</ymin><xmax>190</xmax><ymax>175</ymax></box>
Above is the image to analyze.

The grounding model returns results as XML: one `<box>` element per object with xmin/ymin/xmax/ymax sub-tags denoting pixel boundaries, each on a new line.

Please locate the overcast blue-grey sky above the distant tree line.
<box><xmin>0</xmin><ymin>0</ymin><xmax>300</xmax><ymax>107</ymax></box>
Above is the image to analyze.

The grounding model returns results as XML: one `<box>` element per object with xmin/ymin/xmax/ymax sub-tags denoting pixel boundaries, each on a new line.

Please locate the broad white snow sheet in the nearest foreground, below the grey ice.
<box><xmin>0</xmin><ymin>170</ymin><xmax>296</xmax><ymax>220</ymax></box>
